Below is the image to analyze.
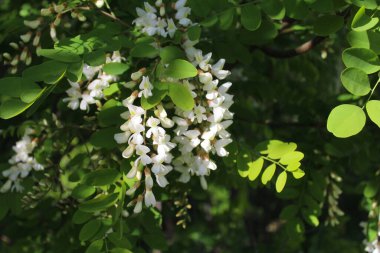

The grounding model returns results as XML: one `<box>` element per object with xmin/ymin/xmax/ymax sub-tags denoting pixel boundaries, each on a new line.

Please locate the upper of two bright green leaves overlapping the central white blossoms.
<box><xmin>164</xmin><ymin>59</ymin><xmax>198</xmax><ymax>79</ymax></box>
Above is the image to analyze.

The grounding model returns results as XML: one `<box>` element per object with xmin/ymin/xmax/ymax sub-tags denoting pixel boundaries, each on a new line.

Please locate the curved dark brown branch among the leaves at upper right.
<box><xmin>258</xmin><ymin>36</ymin><xmax>327</xmax><ymax>58</ymax></box>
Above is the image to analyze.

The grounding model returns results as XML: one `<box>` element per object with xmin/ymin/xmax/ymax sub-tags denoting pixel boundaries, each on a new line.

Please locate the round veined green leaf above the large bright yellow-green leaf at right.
<box><xmin>340</xmin><ymin>68</ymin><xmax>371</xmax><ymax>96</ymax></box>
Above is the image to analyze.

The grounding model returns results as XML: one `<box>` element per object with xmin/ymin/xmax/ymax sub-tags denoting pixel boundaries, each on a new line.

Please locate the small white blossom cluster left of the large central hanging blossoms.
<box><xmin>63</xmin><ymin>52</ymin><xmax>122</xmax><ymax>111</ymax></box>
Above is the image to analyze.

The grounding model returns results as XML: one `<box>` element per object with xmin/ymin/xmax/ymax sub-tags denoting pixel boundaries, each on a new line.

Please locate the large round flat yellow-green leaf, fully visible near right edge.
<box><xmin>327</xmin><ymin>104</ymin><xmax>366</xmax><ymax>138</ymax></box>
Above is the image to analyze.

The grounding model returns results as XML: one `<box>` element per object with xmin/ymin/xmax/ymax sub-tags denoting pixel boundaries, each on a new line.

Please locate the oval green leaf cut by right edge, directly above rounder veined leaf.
<box><xmin>342</xmin><ymin>48</ymin><xmax>380</xmax><ymax>74</ymax></box>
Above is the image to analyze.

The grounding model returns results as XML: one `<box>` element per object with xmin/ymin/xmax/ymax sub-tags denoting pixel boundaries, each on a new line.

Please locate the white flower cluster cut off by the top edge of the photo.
<box><xmin>133</xmin><ymin>0</ymin><xmax>192</xmax><ymax>38</ymax></box>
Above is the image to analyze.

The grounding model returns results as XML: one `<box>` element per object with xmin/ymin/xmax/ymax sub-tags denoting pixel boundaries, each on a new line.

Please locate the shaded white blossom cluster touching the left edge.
<box><xmin>0</xmin><ymin>128</ymin><xmax>44</xmax><ymax>192</ymax></box>
